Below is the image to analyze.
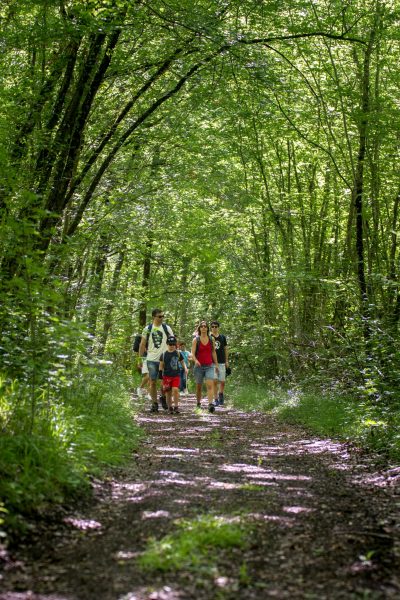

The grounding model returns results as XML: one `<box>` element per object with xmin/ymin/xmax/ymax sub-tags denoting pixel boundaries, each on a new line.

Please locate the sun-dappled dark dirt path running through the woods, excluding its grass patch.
<box><xmin>0</xmin><ymin>397</ymin><xmax>400</xmax><ymax>600</ymax></box>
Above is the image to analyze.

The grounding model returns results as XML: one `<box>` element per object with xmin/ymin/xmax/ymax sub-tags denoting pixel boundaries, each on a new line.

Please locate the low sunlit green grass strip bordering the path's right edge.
<box><xmin>230</xmin><ymin>385</ymin><xmax>400</xmax><ymax>462</ymax></box>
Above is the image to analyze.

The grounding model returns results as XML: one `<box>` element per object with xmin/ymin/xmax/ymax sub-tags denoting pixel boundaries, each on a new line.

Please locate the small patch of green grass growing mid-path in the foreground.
<box><xmin>138</xmin><ymin>514</ymin><xmax>249</xmax><ymax>572</ymax></box>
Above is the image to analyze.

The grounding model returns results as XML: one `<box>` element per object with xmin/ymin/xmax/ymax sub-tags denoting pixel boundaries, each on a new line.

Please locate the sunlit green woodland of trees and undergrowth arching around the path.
<box><xmin>0</xmin><ymin>0</ymin><xmax>400</xmax><ymax>527</ymax></box>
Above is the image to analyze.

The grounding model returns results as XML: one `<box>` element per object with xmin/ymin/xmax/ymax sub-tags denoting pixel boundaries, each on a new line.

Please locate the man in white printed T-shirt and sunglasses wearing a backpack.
<box><xmin>139</xmin><ymin>308</ymin><xmax>174</xmax><ymax>412</ymax></box>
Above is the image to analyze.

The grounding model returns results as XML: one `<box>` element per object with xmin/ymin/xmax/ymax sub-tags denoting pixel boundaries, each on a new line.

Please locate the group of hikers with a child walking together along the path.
<box><xmin>138</xmin><ymin>308</ymin><xmax>230</xmax><ymax>414</ymax></box>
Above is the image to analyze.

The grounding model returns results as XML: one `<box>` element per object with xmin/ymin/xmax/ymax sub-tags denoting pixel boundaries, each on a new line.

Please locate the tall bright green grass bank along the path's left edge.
<box><xmin>0</xmin><ymin>367</ymin><xmax>142</xmax><ymax>530</ymax></box>
